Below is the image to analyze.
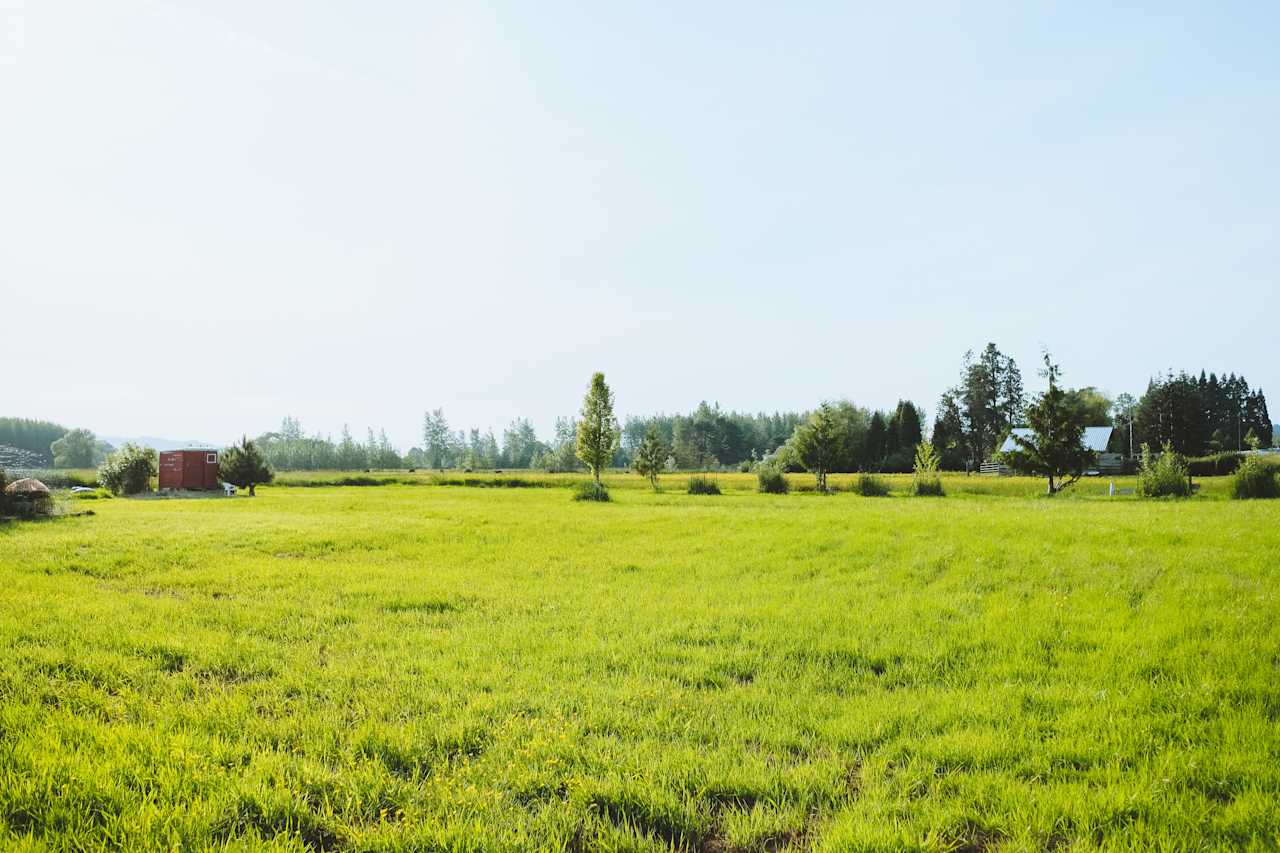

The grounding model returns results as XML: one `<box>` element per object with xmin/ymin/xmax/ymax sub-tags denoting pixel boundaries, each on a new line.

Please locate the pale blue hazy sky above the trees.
<box><xmin>0</xmin><ymin>0</ymin><xmax>1280</xmax><ymax>448</ymax></box>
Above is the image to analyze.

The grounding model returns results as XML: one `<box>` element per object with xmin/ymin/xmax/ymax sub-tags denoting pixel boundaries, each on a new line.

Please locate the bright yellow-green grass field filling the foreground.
<box><xmin>0</xmin><ymin>485</ymin><xmax>1280</xmax><ymax>852</ymax></box>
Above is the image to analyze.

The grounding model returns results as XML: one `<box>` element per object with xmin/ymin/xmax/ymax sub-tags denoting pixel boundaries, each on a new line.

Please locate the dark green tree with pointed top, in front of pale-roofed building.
<box><xmin>1005</xmin><ymin>352</ymin><xmax>1093</xmax><ymax>494</ymax></box>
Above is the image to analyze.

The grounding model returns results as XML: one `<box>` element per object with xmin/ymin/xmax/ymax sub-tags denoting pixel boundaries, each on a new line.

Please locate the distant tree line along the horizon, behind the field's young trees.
<box><xmin>0</xmin><ymin>343</ymin><xmax>1274</xmax><ymax>473</ymax></box>
